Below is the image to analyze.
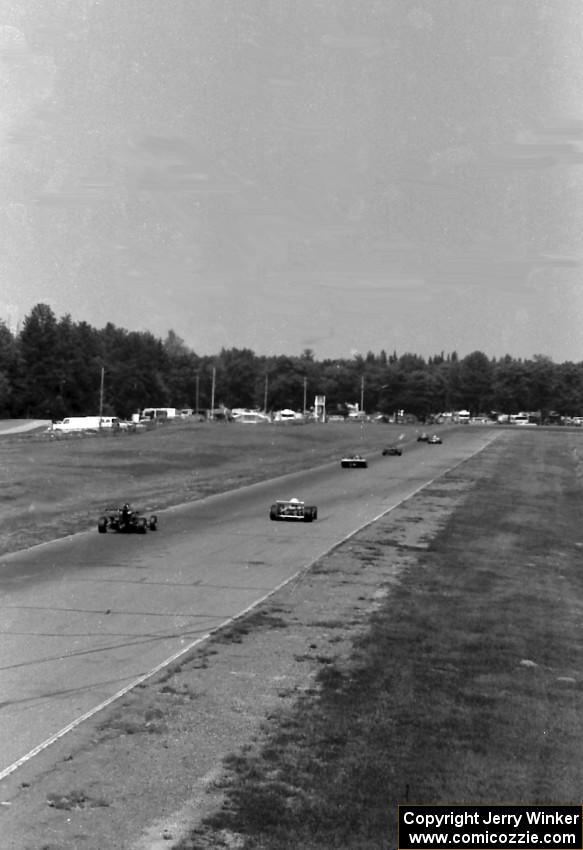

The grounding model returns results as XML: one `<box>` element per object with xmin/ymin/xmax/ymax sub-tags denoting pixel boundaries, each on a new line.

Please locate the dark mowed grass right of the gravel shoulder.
<box><xmin>184</xmin><ymin>432</ymin><xmax>583</xmax><ymax>850</ymax></box>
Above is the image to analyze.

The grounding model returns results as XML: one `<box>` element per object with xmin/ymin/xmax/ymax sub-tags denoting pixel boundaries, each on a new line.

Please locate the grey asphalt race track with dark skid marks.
<box><xmin>0</xmin><ymin>426</ymin><xmax>499</xmax><ymax>779</ymax></box>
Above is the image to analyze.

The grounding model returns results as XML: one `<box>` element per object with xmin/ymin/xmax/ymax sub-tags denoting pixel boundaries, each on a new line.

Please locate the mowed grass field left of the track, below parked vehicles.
<box><xmin>0</xmin><ymin>421</ymin><xmax>402</xmax><ymax>554</ymax></box>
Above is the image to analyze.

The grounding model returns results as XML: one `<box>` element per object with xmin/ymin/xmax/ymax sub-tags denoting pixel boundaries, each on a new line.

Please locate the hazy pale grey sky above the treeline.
<box><xmin>0</xmin><ymin>0</ymin><xmax>583</xmax><ymax>362</ymax></box>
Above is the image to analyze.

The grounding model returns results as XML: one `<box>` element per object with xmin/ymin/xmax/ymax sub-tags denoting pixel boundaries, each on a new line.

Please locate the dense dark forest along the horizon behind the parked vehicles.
<box><xmin>0</xmin><ymin>304</ymin><xmax>583</xmax><ymax>419</ymax></box>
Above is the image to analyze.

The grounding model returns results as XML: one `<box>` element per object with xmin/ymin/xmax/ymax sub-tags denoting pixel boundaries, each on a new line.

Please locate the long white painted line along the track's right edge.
<box><xmin>0</xmin><ymin>435</ymin><xmax>497</xmax><ymax>782</ymax></box>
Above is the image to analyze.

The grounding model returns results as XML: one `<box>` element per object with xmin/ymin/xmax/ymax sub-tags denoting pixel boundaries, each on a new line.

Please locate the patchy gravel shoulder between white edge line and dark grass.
<box><xmin>0</xmin><ymin>440</ymin><xmax>488</xmax><ymax>850</ymax></box>
